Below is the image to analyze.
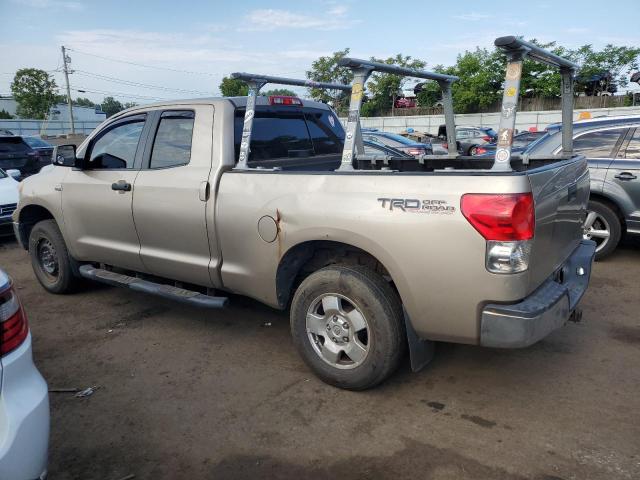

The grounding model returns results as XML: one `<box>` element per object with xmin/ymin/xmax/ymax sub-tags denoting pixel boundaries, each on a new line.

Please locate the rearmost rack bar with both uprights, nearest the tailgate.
<box><xmin>492</xmin><ymin>35</ymin><xmax>580</xmax><ymax>171</ymax></box>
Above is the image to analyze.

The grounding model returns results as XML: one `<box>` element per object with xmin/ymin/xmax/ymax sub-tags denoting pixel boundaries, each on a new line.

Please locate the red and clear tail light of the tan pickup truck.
<box><xmin>460</xmin><ymin>193</ymin><xmax>535</xmax><ymax>273</ymax></box>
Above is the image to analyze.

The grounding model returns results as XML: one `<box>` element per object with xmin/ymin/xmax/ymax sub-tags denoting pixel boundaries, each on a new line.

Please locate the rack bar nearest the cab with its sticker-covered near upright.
<box><xmin>231</xmin><ymin>72</ymin><xmax>351</xmax><ymax>170</ymax></box>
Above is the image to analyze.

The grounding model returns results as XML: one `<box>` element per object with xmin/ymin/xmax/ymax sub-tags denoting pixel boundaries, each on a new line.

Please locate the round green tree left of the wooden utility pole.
<box><xmin>11</xmin><ymin>68</ymin><xmax>57</xmax><ymax>119</ymax></box>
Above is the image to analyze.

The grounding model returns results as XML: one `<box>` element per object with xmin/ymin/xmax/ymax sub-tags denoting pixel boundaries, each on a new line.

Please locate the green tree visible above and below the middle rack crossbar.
<box><xmin>362</xmin><ymin>53</ymin><xmax>426</xmax><ymax>117</ymax></box>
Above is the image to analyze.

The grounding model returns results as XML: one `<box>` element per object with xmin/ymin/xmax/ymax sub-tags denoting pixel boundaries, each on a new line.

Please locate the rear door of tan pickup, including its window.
<box><xmin>133</xmin><ymin>105</ymin><xmax>217</xmax><ymax>286</ymax></box>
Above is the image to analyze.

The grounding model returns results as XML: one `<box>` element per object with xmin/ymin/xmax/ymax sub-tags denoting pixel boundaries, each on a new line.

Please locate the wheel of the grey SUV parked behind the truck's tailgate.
<box><xmin>583</xmin><ymin>200</ymin><xmax>622</xmax><ymax>260</ymax></box>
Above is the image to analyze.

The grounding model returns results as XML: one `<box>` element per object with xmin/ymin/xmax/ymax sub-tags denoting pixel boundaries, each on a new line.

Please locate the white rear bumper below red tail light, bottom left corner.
<box><xmin>0</xmin><ymin>334</ymin><xmax>49</xmax><ymax>480</ymax></box>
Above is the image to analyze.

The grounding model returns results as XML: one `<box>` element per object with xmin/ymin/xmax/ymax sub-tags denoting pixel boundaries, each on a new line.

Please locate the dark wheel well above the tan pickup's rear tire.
<box><xmin>276</xmin><ymin>240</ymin><xmax>397</xmax><ymax>308</ymax></box>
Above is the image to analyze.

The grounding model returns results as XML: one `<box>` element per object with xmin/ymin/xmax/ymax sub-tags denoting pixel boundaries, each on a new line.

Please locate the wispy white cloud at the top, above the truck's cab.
<box><xmin>240</xmin><ymin>6</ymin><xmax>359</xmax><ymax>31</ymax></box>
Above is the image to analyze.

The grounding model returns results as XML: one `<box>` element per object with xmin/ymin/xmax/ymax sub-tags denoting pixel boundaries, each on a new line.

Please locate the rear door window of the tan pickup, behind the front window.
<box><xmin>150</xmin><ymin>111</ymin><xmax>195</xmax><ymax>168</ymax></box>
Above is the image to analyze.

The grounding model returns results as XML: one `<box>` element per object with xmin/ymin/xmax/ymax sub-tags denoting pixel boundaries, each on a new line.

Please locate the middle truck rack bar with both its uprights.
<box><xmin>338</xmin><ymin>57</ymin><xmax>458</xmax><ymax>170</ymax></box>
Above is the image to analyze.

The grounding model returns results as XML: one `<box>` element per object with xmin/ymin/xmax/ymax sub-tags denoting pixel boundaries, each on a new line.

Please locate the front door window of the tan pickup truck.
<box><xmin>88</xmin><ymin>118</ymin><xmax>144</xmax><ymax>169</ymax></box>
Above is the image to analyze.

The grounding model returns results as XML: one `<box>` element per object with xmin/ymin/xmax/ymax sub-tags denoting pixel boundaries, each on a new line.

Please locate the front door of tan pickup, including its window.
<box><xmin>61</xmin><ymin>114</ymin><xmax>146</xmax><ymax>271</ymax></box>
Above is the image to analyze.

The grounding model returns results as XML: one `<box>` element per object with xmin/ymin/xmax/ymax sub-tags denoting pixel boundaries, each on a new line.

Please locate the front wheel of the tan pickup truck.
<box><xmin>29</xmin><ymin>220</ymin><xmax>79</xmax><ymax>293</ymax></box>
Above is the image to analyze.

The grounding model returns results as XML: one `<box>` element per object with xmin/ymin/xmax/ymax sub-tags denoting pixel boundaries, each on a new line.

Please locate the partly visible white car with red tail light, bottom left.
<box><xmin>0</xmin><ymin>270</ymin><xmax>49</xmax><ymax>480</ymax></box>
